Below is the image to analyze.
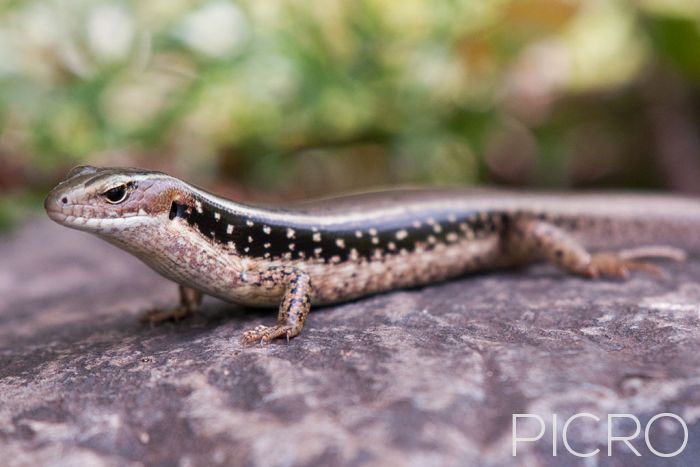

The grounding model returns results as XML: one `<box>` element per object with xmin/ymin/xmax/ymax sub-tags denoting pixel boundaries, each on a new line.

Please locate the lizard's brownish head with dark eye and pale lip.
<box><xmin>44</xmin><ymin>166</ymin><xmax>177</xmax><ymax>235</ymax></box>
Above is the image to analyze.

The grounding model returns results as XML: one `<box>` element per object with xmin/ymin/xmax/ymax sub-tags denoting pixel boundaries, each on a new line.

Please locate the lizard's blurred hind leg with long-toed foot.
<box><xmin>505</xmin><ymin>218</ymin><xmax>685</xmax><ymax>278</ymax></box>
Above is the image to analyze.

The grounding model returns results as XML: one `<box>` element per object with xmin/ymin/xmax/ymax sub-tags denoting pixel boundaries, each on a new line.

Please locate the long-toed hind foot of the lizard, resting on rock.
<box><xmin>585</xmin><ymin>246</ymin><xmax>686</xmax><ymax>279</ymax></box>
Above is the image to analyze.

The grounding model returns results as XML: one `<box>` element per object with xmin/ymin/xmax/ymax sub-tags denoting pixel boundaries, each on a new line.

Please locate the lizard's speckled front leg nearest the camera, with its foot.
<box><xmin>243</xmin><ymin>271</ymin><xmax>311</xmax><ymax>344</ymax></box>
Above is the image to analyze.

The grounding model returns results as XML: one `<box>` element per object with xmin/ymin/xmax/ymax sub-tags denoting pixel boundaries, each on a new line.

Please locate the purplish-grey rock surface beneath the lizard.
<box><xmin>0</xmin><ymin>220</ymin><xmax>700</xmax><ymax>466</ymax></box>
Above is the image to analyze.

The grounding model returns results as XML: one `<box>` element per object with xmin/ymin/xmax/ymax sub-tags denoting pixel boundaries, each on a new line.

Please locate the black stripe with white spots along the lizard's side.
<box><xmin>170</xmin><ymin>198</ymin><xmax>508</xmax><ymax>261</ymax></box>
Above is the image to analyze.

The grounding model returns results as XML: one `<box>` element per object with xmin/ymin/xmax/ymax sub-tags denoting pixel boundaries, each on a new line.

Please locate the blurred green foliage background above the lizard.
<box><xmin>0</xmin><ymin>0</ymin><xmax>700</xmax><ymax>228</ymax></box>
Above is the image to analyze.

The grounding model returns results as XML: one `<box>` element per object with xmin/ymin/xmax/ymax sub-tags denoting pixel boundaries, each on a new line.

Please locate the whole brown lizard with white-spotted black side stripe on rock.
<box><xmin>45</xmin><ymin>166</ymin><xmax>700</xmax><ymax>343</ymax></box>
